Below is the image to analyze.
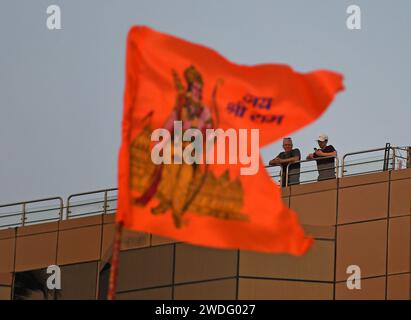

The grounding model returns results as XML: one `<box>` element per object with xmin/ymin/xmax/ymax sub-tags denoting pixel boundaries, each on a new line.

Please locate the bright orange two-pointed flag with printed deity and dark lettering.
<box><xmin>116</xmin><ymin>26</ymin><xmax>343</xmax><ymax>255</ymax></box>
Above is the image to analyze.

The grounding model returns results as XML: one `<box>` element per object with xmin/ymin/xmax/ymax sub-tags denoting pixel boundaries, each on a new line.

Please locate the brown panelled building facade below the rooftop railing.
<box><xmin>0</xmin><ymin>169</ymin><xmax>411</xmax><ymax>300</ymax></box>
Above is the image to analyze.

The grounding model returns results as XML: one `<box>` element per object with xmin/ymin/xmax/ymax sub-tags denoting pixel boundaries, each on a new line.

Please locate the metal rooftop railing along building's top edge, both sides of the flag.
<box><xmin>0</xmin><ymin>144</ymin><xmax>411</xmax><ymax>229</ymax></box>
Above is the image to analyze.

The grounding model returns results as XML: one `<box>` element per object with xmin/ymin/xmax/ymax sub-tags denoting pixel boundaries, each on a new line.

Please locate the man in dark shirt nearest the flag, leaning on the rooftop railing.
<box><xmin>269</xmin><ymin>138</ymin><xmax>301</xmax><ymax>187</ymax></box>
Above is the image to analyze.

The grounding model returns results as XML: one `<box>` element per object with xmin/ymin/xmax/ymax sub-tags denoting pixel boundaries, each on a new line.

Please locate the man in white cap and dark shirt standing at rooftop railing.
<box><xmin>307</xmin><ymin>134</ymin><xmax>337</xmax><ymax>181</ymax></box>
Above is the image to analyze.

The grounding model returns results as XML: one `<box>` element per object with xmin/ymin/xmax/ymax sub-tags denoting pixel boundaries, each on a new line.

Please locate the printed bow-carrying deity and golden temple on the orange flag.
<box><xmin>130</xmin><ymin>65</ymin><xmax>247</xmax><ymax>228</ymax></box>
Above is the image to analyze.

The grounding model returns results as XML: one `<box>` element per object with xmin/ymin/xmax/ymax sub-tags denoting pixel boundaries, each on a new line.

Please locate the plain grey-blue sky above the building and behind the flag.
<box><xmin>0</xmin><ymin>0</ymin><xmax>411</xmax><ymax>203</ymax></box>
